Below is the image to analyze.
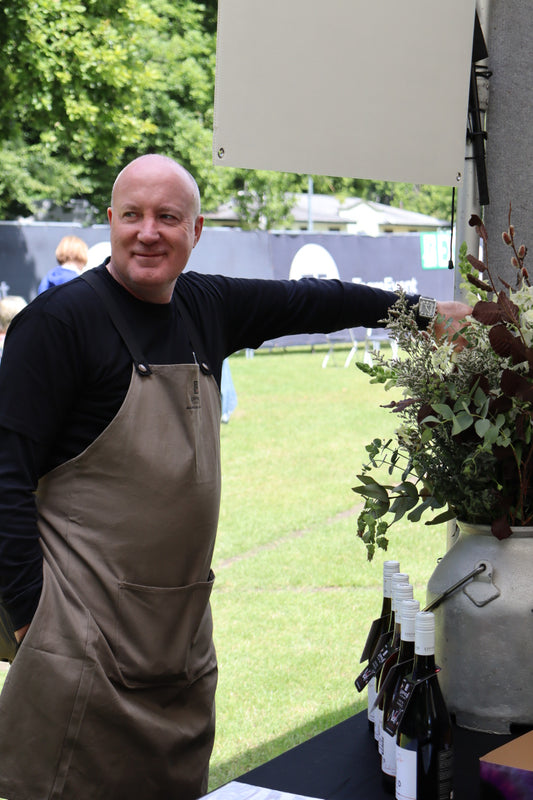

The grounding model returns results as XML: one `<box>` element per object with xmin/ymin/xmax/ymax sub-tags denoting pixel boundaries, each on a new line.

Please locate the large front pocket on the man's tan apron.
<box><xmin>115</xmin><ymin>571</ymin><xmax>215</xmax><ymax>686</ymax></box>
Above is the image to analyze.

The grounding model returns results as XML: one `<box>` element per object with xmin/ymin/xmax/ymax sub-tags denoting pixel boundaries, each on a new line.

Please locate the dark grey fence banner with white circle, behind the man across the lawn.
<box><xmin>0</xmin><ymin>223</ymin><xmax>453</xmax><ymax>345</ymax></box>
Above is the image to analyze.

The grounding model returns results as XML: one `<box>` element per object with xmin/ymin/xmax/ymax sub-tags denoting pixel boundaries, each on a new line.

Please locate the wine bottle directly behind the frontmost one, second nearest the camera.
<box><xmin>381</xmin><ymin>599</ymin><xmax>420</xmax><ymax>794</ymax></box>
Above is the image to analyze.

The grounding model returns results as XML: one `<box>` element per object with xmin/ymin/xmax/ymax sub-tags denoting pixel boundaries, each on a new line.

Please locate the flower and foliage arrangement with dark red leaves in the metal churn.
<box><xmin>354</xmin><ymin>211</ymin><xmax>533</xmax><ymax>559</ymax></box>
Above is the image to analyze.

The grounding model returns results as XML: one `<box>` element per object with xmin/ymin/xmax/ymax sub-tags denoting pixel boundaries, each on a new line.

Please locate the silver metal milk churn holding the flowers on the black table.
<box><xmin>427</xmin><ymin>522</ymin><xmax>533</xmax><ymax>733</ymax></box>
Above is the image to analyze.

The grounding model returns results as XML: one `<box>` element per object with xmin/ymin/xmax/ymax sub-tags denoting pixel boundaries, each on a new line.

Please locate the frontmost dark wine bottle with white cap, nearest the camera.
<box><xmin>396</xmin><ymin>611</ymin><xmax>453</xmax><ymax>800</ymax></box>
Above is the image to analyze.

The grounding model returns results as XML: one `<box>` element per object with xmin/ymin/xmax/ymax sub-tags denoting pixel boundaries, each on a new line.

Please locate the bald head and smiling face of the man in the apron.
<box><xmin>107</xmin><ymin>155</ymin><xmax>203</xmax><ymax>303</ymax></box>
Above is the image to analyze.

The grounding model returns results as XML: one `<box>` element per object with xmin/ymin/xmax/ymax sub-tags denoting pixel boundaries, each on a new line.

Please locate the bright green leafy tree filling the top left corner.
<box><xmin>0</xmin><ymin>0</ymin><xmax>157</xmax><ymax>217</ymax></box>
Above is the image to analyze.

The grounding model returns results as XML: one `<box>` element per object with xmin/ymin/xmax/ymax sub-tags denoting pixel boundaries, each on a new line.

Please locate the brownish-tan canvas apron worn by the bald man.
<box><xmin>0</xmin><ymin>278</ymin><xmax>220</xmax><ymax>800</ymax></box>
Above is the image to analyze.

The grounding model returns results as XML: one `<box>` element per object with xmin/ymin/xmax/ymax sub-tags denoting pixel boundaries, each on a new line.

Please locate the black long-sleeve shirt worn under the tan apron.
<box><xmin>0</xmin><ymin>266</ymin><xmax>418</xmax><ymax>629</ymax></box>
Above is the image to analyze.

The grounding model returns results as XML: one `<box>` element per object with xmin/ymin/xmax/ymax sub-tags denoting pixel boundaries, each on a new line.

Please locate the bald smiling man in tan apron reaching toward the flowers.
<box><xmin>0</xmin><ymin>155</ymin><xmax>468</xmax><ymax>800</ymax></box>
